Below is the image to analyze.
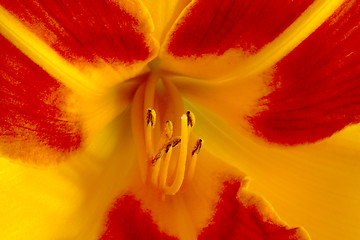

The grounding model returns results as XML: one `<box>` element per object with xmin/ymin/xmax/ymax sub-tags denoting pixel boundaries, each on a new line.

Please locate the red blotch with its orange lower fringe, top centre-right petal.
<box><xmin>160</xmin><ymin>0</ymin><xmax>314</xmax><ymax>78</ymax></box>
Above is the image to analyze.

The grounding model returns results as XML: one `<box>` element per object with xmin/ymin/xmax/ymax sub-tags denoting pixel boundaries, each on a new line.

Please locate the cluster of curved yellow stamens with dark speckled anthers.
<box><xmin>145</xmin><ymin>108</ymin><xmax>203</xmax><ymax>196</ymax></box>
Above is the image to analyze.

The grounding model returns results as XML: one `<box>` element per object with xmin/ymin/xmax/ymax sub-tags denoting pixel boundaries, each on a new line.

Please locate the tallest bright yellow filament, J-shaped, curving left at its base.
<box><xmin>165</xmin><ymin>114</ymin><xmax>189</xmax><ymax>195</ymax></box>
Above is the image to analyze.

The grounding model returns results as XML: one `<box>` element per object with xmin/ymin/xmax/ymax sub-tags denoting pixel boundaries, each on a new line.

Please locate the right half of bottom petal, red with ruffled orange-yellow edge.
<box><xmin>198</xmin><ymin>181</ymin><xmax>310</xmax><ymax>240</ymax></box>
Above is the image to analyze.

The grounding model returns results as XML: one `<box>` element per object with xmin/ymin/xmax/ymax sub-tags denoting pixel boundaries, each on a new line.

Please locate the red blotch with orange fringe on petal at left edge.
<box><xmin>0</xmin><ymin>36</ymin><xmax>84</xmax><ymax>163</ymax></box>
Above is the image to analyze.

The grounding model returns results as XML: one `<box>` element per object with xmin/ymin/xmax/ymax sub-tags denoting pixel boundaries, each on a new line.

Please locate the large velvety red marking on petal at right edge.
<box><xmin>250</xmin><ymin>0</ymin><xmax>360</xmax><ymax>144</ymax></box>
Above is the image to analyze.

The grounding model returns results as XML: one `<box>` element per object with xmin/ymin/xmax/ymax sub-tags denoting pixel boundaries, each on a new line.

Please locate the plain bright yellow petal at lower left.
<box><xmin>0</xmin><ymin>109</ymin><xmax>135</xmax><ymax>240</ymax></box>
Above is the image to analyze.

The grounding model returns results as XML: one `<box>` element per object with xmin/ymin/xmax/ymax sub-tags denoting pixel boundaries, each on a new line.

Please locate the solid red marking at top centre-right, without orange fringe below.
<box><xmin>169</xmin><ymin>0</ymin><xmax>313</xmax><ymax>56</ymax></box>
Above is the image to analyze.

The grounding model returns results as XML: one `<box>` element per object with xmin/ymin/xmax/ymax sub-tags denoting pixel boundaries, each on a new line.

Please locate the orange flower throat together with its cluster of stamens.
<box><xmin>132</xmin><ymin>72</ymin><xmax>202</xmax><ymax>196</ymax></box>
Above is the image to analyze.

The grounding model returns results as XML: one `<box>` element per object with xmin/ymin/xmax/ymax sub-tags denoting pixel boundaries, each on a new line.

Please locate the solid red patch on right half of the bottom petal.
<box><xmin>198</xmin><ymin>181</ymin><xmax>304</xmax><ymax>240</ymax></box>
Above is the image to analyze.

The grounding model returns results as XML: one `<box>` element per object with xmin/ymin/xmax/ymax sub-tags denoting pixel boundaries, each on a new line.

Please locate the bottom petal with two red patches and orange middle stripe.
<box><xmin>101</xmin><ymin>151</ymin><xmax>308</xmax><ymax>240</ymax></box>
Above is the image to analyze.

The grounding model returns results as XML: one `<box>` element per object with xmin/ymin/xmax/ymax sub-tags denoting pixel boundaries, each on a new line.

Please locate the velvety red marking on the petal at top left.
<box><xmin>0</xmin><ymin>0</ymin><xmax>149</xmax><ymax>63</ymax></box>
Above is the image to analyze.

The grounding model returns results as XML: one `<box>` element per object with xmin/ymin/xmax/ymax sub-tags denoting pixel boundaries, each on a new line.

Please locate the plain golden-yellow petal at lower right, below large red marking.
<box><xmin>187</xmin><ymin>100</ymin><xmax>360</xmax><ymax>240</ymax></box>
